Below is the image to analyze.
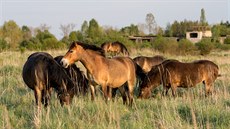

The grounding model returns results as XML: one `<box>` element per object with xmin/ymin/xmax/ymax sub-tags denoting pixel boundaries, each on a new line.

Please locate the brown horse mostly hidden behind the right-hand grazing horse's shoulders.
<box><xmin>133</xmin><ymin>55</ymin><xmax>165</xmax><ymax>73</ymax></box>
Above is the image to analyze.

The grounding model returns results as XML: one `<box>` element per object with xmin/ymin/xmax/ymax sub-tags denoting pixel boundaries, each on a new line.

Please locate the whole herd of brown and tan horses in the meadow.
<box><xmin>22</xmin><ymin>42</ymin><xmax>219</xmax><ymax>108</ymax></box>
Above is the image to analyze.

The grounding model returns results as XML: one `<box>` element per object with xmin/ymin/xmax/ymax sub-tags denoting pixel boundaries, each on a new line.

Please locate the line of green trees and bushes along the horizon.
<box><xmin>0</xmin><ymin>9</ymin><xmax>230</xmax><ymax>54</ymax></box>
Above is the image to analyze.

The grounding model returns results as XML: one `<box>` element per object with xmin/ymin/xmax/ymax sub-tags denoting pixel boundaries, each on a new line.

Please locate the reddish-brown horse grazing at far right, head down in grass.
<box><xmin>140</xmin><ymin>60</ymin><xmax>220</xmax><ymax>98</ymax></box>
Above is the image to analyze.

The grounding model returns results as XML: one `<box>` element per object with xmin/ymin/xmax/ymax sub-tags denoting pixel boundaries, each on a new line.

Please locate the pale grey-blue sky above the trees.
<box><xmin>0</xmin><ymin>0</ymin><xmax>230</xmax><ymax>38</ymax></box>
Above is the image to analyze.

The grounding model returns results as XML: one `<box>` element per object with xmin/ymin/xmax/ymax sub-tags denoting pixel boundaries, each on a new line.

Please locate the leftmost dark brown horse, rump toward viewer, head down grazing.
<box><xmin>22</xmin><ymin>52</ymin><xmax>74</xmax><ymax>109</ymax></box>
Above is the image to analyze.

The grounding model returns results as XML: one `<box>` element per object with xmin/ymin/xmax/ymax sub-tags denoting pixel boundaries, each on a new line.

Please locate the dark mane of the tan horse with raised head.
<box><xmin>70</xmin><ymin>42</ymin><xmax>105</xmax><ymax>56</ymax></box>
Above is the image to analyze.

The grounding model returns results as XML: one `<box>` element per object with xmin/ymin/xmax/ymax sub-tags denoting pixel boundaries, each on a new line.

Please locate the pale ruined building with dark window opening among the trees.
<box><xmin>186</xmin><ymin>26</ymin><xmax>212</xmax><ymax>43</ymax></box>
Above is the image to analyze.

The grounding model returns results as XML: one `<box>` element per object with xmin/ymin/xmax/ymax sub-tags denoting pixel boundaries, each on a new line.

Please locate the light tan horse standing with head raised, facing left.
<box><xmin>61</xmin><ymin>42</ymin><xmax>136</xmax><ymax>106</ymax></box>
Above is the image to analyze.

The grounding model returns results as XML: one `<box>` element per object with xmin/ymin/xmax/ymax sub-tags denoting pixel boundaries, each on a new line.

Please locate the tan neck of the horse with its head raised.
<box><xmin>80</xmin><ymin>51</ymin><xmax>105</xmax><ymax>74</ymax></box>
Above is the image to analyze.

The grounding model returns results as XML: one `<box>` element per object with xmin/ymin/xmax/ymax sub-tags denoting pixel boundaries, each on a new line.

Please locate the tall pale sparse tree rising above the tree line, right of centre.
<box><xmin>145</xmin><ymin>13</ymin><xmax>157</xmax><ymax>34</ymax></box>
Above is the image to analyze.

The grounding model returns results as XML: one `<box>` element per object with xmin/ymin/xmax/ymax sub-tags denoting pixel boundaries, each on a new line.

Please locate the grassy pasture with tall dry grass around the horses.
<box><xmin>0</xmin><ymin>49</ymin><xmax>230</xmax><ymax>129</ymax></box>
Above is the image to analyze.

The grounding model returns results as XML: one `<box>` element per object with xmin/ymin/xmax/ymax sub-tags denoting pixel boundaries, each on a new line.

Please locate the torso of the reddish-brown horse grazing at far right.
<box><xmin>164</xmin><ymin>60</ymin><xmax>218</xmax><ymax>87</ymax></box>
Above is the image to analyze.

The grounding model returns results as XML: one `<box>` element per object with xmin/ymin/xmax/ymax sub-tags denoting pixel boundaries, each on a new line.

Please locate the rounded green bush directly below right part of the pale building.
<box><xmin>196</xmin><ymin>39</ymin><xmax>215</xmax><ymax>55</ymax></box>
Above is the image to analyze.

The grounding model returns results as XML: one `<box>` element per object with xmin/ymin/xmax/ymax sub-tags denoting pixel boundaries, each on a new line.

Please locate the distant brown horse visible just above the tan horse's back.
<box><xmin>101</xmin><ymin>41</ymin><xmax>129</xmax><ymax>56</ymax></box>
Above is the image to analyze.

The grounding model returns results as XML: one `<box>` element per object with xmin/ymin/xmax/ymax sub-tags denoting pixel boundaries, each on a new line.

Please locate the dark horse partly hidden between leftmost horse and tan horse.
<box><xmin>54</xmin><ymin>56</ymin><xmax>89</xmax><ymax>96</ymax></box>
